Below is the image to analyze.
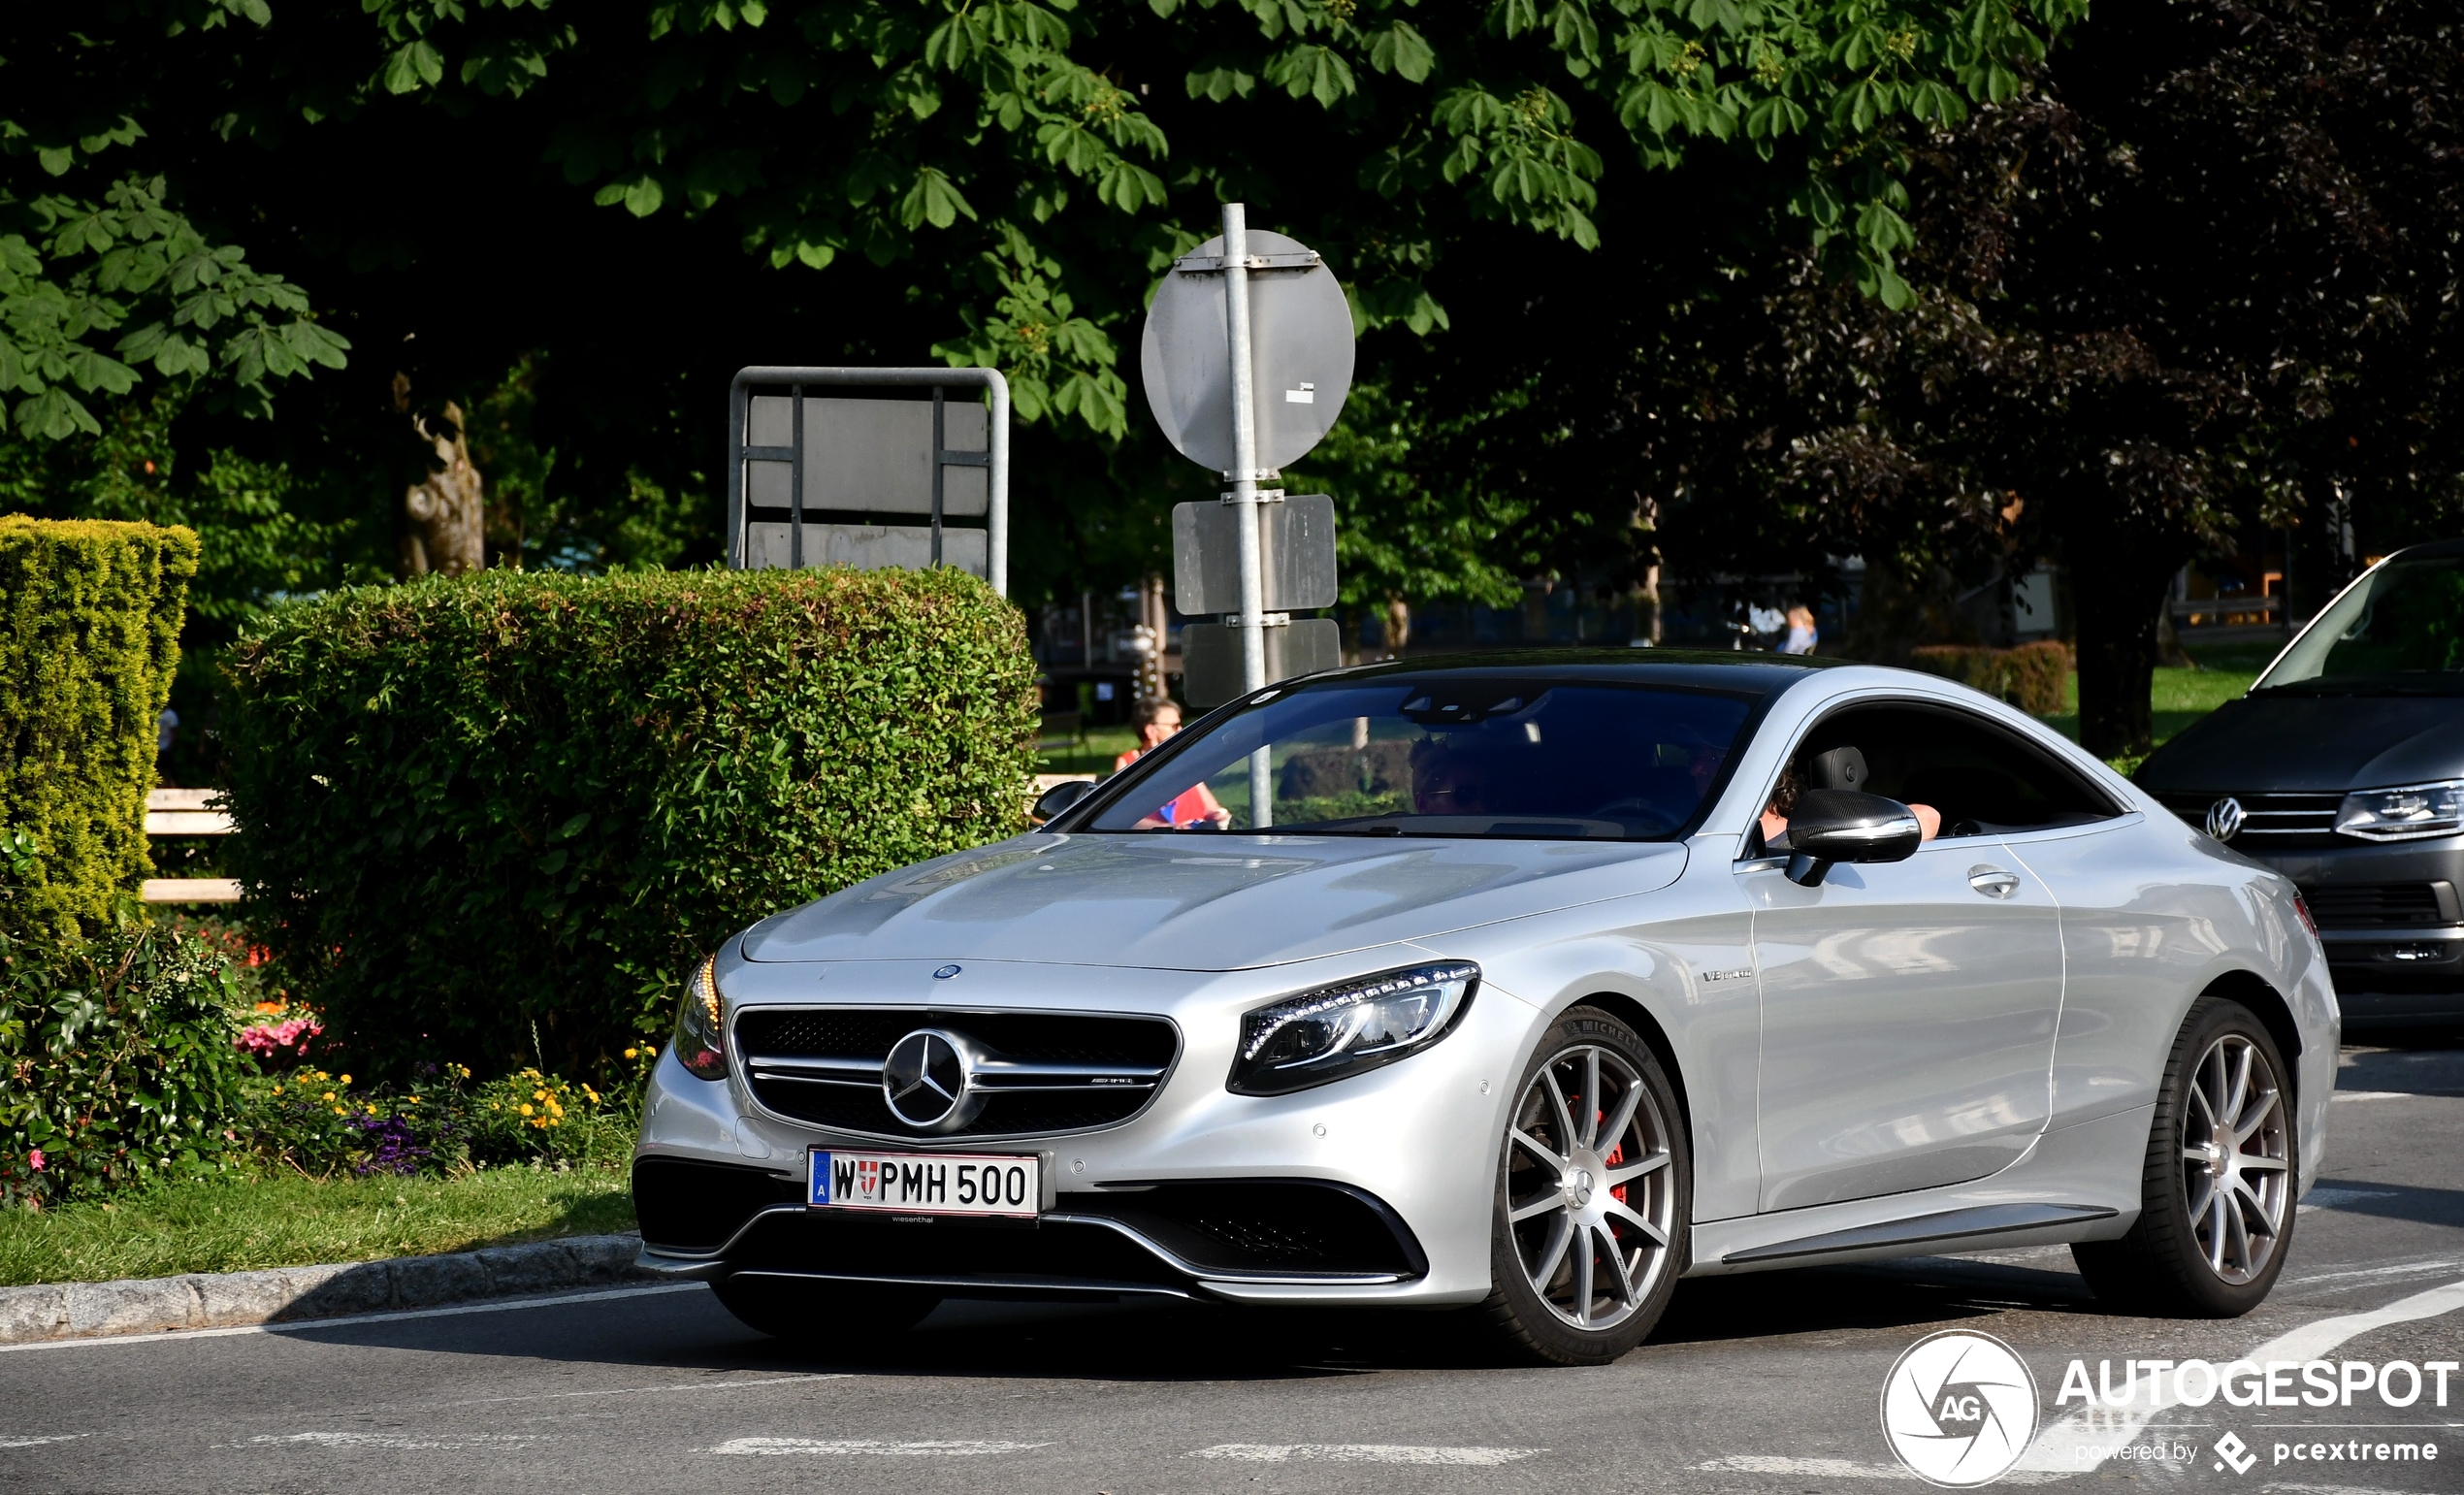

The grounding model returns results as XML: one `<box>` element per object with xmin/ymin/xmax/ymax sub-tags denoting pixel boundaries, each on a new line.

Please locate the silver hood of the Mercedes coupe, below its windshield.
<box><xmin>744</xmin><ymin>835</ymin><xmax>1685</xmax><ymax>970</ymax></box>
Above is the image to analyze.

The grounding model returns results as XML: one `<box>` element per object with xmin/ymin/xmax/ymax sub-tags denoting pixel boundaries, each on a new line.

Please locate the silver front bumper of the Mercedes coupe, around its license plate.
<box><xmin>635</xmin><ymin>948</ymin><xmax>1533</xmax><ymax>1306</ymax></box>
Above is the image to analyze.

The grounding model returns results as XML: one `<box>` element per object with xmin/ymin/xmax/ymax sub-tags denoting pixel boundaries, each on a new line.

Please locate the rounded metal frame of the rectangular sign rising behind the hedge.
<box><xmin>727</xmin><ymin>367</ymin><xmax>1010</xmax><ymax>596</ymax></box>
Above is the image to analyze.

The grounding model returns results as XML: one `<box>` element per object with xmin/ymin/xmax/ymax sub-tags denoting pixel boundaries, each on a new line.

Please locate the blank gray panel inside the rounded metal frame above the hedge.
<box><xmin>744</xmin><ymin>394</ymin><xmax>993</xmax><ymax>520</ymax></box>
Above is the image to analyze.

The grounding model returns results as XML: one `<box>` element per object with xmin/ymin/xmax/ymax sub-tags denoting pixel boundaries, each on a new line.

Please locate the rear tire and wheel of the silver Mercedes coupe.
<box><xmin>2070</xmin><ymin>995</ymin><xmax>2301</xmax><ymax>1317</ymax></box>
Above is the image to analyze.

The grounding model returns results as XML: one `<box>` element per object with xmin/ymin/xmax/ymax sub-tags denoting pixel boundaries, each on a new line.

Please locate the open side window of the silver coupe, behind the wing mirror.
<box><xmin>1792</xmin><ymin>704</ymin><xmax>2117</xmax><ymax>840</ymax></box>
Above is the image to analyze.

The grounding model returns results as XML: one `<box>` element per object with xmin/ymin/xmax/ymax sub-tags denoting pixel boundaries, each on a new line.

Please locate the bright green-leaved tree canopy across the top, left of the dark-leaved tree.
<box><xmin>0</xmin><ymin>0</ymin><xmax>2085</xmax><ymax>620</ymax></box>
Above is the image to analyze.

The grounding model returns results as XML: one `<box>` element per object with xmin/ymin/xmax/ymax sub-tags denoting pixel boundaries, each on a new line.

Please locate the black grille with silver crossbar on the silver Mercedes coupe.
<box><xmin>736</xmin><ymin>1007</ymin><xmax>1181</xmax><ymax>1143</ymax></box>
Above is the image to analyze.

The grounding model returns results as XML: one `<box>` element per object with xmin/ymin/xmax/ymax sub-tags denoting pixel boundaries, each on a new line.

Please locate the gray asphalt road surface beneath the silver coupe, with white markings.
<box><xmin>0</xmin><ymin>1039</ymin><xmax>2464</xmax><ymax>1495</ymax></box>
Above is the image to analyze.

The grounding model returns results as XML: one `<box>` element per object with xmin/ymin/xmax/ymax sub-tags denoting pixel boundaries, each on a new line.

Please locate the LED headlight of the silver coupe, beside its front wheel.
<box><xmin>1227</xmin><ymin>960</ymin><xmax>1481</xmax><ymax>1096</ymax></box>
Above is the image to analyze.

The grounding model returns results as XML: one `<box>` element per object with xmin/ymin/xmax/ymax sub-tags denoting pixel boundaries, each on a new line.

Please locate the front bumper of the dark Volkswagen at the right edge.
<box><xmin>2253</xmin><ymin>837</ymin><xmax>2464</xmax><ymax>1024</ymax></box>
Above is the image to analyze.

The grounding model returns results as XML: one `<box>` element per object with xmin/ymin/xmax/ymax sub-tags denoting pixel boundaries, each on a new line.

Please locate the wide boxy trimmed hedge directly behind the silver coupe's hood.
<box><xmin>224</xmin><ymin>569</ymin><xmax>1035</xmax><ymax>1076</ymax></box>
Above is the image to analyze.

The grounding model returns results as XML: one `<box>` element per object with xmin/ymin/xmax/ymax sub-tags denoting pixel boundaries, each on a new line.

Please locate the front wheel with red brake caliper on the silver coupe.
<box><xmin>1481</xmin><ymin>1007</ymin><xmax>1693</xmax><ymax>1364</ymax></box>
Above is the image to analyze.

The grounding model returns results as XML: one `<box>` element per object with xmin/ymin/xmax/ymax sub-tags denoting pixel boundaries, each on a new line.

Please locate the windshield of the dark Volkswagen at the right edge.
<box><xmin>2257</xmin><ymin>557</ymin><xmax>2464</xmax><ymax>695</ymax></box>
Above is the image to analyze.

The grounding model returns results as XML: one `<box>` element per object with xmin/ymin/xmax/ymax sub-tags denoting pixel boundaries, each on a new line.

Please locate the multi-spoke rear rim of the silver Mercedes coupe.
<box><xmin>2181</xmin><ymin>1032</ymin><xmax>2291</xmax><ymax>1285</ymax></box>
